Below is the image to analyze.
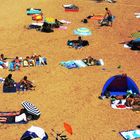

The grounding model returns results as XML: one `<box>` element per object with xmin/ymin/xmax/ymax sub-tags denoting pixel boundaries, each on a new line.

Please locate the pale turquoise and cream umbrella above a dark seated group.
<box><xmin>73</xmin><ymin>27</ymin><xmax>92</xmax><ymax>36</ymax></box>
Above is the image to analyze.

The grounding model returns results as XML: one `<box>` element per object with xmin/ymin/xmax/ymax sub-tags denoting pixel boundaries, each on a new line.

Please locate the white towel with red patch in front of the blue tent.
<box><xmin>111</xmin><ymin>100</ymin><xmax>132</xmax><ymax>109</ymax></box>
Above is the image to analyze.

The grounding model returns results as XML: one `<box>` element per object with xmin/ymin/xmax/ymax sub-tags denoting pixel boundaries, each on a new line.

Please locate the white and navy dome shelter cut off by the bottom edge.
<box><xmin>20</xmin><ymin>126</ymin><xmax>48</xmax><ymax>140</ymax></box>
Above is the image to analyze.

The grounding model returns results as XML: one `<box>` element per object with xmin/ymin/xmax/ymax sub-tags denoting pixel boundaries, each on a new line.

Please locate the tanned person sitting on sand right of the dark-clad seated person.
<box><xmin>19</xmin><ymin>76</ymin><xmax>35</xmax><ymax>90</ymax></box>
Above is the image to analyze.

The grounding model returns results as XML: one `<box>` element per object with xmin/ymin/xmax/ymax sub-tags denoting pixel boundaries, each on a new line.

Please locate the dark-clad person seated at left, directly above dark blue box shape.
<box><xmin>3</xmin><ymin>74</ymin><xmax>15</xmax><ymax>87</ymax></box>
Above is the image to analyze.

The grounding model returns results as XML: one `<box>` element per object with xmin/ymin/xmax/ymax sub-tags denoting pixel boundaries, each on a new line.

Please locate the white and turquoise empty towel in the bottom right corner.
<box><xmin>120</xmin><ymin>130</ymin><xmax>140</xmax><ymax>140</ymax></box>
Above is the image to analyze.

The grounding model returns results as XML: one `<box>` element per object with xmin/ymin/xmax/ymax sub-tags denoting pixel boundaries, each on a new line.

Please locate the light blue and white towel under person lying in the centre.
<box><xmin>60</xmin><ymin>59</ymin><xmax>103</xmax><ymax>69</ymax></box>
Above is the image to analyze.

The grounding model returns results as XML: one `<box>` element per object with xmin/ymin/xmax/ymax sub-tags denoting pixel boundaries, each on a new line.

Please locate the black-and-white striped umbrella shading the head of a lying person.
<box><xmin>21</xmin><ymin>101</ymin><xmax>41</xmax><ymax>116</ymax></box>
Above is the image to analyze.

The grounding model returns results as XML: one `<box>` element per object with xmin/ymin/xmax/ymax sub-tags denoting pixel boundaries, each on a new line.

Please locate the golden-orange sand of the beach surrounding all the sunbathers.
<box><xmin>0</xmin><ymin>0</ymin><xmax>140</xmax><ymax>140</ymax></box>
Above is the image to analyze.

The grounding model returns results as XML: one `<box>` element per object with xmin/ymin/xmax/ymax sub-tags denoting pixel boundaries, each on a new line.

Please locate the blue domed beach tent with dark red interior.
<box><xmin>101</xmin><ymin>75</ymin><xmax>140</xmax><ymax>96</ymax></box>
